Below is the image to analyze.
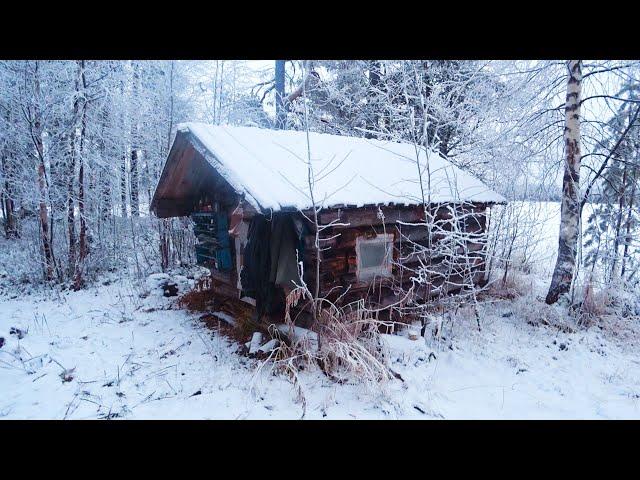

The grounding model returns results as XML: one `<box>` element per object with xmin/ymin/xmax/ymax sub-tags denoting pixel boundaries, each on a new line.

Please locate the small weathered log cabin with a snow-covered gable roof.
<box><xmin>151</xmin><ymin>123</ymin><xmax>505</xmax><ymax>318</ymax></box>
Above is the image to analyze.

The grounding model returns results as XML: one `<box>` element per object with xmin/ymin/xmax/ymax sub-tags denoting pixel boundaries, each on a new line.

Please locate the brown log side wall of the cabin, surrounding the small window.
<box><xmin>304</xmin><ymin>204</ymin><xmax>487</xmax><ymax>305</ymax></box>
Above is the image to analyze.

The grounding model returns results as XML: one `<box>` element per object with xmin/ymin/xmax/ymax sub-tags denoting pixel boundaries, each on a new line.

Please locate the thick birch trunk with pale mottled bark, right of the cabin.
<box><xmin>546</xmin><ymin>60</ymin><xmax>582</xmax><ymax>304</ymax></box>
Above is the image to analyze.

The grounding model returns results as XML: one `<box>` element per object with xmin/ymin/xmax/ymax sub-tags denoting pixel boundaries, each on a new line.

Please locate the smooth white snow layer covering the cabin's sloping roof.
<box><xmin>178</xmin><ymin>123</ymin><xmax>505</xmax><ymax>211</ymax></box>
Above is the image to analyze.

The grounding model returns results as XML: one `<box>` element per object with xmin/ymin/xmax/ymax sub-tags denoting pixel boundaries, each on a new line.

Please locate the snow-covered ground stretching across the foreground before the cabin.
<box><xmin>0</xmin><ymin>204</ymin><xmax>640</xmax><ymax>419</ymax></box>
